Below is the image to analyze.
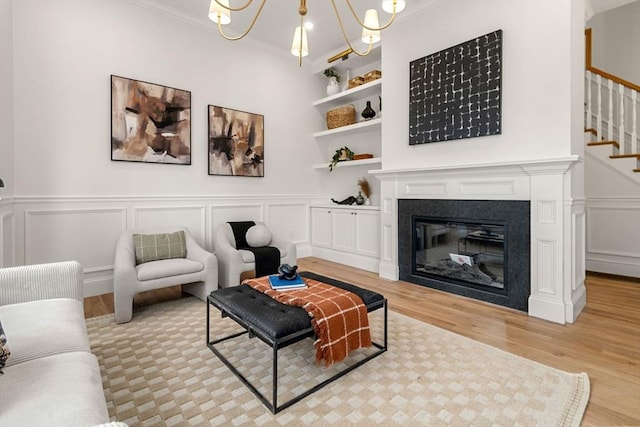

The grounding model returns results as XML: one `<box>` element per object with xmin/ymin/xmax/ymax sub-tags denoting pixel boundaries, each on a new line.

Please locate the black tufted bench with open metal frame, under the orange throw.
<box><xmin>206</xmin><ymin>272</ymin><xmax>387</xmax><ymax>414</ymax></box>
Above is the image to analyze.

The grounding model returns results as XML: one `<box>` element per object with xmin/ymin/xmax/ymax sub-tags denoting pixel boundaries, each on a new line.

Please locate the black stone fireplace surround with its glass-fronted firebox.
<box><xmin>398</xmin><ymin>199</ymin><xmax>531</xmax><ymax>311</ymax></box>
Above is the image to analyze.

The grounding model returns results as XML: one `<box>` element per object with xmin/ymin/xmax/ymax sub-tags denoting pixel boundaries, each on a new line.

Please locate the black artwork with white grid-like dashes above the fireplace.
<box><xmin>409</xmin><ymin>30</ymin><xmax>502</xmax><ymax>145</ymax></box>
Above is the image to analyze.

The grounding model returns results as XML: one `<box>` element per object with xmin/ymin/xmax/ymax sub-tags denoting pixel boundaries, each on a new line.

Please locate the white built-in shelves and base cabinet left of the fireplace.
<box><xmin>310</xmin><ymin>53</ymin><xmax>382</xmax><ymax>272</ymax></box>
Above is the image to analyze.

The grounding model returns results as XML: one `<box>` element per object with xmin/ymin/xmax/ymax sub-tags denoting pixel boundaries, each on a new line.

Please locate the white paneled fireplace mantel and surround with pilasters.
<box><xmin>369</xmin><ymin>156</ymin><xmax>586</xmax><ymax>323</ymax></box>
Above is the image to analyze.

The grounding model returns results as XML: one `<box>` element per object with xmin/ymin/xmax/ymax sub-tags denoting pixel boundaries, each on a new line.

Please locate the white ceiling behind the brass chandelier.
<box><xmin>137</xmin><ymin>0</ymin><xmax>443</xmax><ymax>64</ymax></box>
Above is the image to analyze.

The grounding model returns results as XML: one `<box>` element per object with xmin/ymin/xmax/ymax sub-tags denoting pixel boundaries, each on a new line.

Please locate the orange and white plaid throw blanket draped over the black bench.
<box><xmin>242</xmin><ymin>276</ymin><xmax>371</xmax><ymax>366</ymax></box>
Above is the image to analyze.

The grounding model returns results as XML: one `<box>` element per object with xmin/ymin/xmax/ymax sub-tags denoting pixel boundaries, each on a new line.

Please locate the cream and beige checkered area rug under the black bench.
<box><xmin>87</xmin><ymin>297</ymin><xmax>589</xmax><ymax>426</ymax></box>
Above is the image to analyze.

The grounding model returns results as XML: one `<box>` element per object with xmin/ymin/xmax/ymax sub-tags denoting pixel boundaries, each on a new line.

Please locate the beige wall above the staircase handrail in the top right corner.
<box><xmin>587</xmin><ymin>0</ymin><xmax>640</xmax><ymax>85</ymax></box>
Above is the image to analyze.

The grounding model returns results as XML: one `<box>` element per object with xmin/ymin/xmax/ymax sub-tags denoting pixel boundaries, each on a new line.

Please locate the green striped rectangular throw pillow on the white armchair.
<box><xmin>133</xmin><ymin>231</ymin><xmax>187</xmax><ymax>265</ymax></box>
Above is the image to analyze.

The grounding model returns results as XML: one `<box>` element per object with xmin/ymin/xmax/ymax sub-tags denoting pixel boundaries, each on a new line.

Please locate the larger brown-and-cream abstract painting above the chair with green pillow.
<box><xmin>111</xmin><ymin>75</ymin><xmax>191</xmax><ymax>165</ymax></box>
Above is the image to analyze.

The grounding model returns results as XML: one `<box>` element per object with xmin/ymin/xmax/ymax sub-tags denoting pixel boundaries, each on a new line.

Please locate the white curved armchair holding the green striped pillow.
<box><xmin>113</xmin><ymin>227</ymin><xmax>218</xmax><ymax>323</ymax></box>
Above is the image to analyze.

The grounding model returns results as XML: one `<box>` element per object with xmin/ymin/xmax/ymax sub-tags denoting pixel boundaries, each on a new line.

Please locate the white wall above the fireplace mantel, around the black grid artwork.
<box><xmin>382</xmin><ymin>0</ymin><xmax>572</xmax><ymax>169</ymax></box>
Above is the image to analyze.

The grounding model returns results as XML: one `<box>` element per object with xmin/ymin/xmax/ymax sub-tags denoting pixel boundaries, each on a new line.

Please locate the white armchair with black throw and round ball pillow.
<box><xmin>213</xmin><ymin>222</ymin><xmax>297</xmax><ymax>288</ymax></box>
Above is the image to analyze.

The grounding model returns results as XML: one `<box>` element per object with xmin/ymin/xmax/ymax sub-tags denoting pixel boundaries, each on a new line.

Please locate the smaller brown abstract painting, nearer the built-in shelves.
<box><xmin>208</xmin><ymin>105</ymin><xmax>264</xmax><ymax>177</ymax></box>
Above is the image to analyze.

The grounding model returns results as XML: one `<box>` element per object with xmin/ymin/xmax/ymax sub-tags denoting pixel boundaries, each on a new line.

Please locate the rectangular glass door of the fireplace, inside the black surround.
<box><xmin>413</xmin><ymin>221</ymin><xmax>506</xmax><ymax>291</ymax></box>
